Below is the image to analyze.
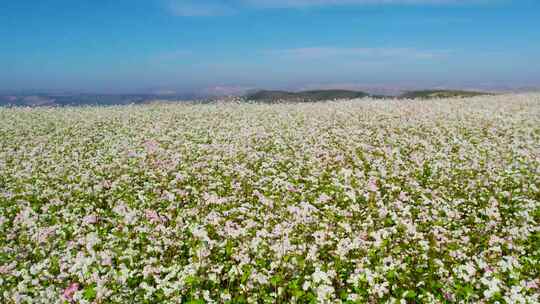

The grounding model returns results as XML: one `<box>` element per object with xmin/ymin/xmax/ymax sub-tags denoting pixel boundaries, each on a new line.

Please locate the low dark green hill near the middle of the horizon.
<box><xmin>245</xmin><ymin>90</ymin><xmax>369</xmax><ymax>102</ymax></box>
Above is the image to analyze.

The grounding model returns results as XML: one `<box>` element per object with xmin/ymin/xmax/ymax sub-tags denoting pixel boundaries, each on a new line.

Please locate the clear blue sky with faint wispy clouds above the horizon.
<box><xmin>0</xmin><ymin>0</ymin><xmax>540</xmax><ymax>93</ymax></box>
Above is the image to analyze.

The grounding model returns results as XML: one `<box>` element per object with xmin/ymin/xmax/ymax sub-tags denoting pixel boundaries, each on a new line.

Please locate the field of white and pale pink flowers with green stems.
<box><xmin>0</xmin><ymin>94</ymin><xmax>540</xmax><ymax>303</ymax></box>
